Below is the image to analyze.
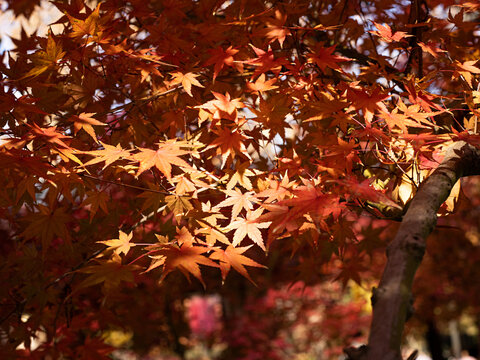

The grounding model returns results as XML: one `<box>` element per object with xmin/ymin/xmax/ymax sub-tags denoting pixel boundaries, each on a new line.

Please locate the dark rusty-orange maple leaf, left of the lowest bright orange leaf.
<box><xmin>157</xmin><ymin>243</ymin><xmax>219</xmax><ymax>287</ymax></box>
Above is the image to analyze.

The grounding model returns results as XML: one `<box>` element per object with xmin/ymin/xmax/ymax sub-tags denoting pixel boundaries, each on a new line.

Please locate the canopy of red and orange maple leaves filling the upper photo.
<box><xmin>0</xmin><ymin>0</ymin><xmax>480</xmax><ymax>359</ymax></box>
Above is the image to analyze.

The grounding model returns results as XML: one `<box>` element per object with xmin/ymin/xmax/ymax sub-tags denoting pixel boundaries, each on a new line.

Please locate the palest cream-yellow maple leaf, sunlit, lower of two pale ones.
<box><xmin>227</xmin><ymin>208</ymin><xmax>271</xmax><ymax>251</ymax></box>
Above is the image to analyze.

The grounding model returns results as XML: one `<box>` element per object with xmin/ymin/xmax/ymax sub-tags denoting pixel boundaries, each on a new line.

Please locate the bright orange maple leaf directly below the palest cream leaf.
<box><xmin>210</xmin><ymin>245</ymin><xmax>266</xmax><ymax>284</ymax></box>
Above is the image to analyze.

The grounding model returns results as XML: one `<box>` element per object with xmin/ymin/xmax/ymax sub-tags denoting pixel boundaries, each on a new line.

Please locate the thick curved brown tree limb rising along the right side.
<box><xmin>349</xmin><ymin>141</ymin><xmax>480</xmax><ymax>360</ymax></box>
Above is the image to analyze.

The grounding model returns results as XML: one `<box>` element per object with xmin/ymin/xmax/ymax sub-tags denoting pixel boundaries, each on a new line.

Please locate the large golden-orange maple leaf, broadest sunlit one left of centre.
<box><xmin>133</xmin><ymin>141</ymin><xmax>193</xmax><ymax>180</ymax></box>
